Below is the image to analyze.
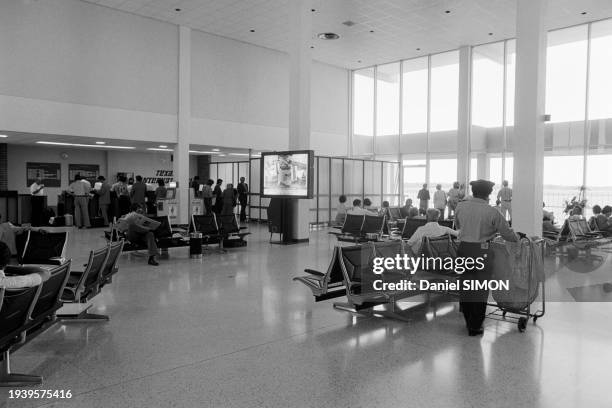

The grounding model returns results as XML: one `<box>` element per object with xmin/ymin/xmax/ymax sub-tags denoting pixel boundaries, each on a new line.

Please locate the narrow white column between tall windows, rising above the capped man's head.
<box><xmin>457</xmin><ymin>45</ymin><xmax>475</xmax><ymax>186</ymax></box>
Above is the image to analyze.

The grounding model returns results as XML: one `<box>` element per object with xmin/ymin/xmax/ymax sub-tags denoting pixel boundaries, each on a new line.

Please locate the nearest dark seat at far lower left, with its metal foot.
<box><xmin>0</xmin><ymin>285</ymin><xmax>42</xmax><ymax>387</ymax></box>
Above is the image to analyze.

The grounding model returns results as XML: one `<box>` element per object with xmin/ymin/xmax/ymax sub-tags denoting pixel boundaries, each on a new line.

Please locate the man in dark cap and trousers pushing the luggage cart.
<box><xmin>455</xmin><ymin>180</ymin><xmax>519</xmax><ymax>336</ymax></box>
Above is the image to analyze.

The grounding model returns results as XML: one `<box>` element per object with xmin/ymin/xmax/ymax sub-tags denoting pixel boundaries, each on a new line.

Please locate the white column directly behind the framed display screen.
<box><xmin>289</xmin><ymin>0</ymin><xmax>312</xmax><ymax>241</ymax></box>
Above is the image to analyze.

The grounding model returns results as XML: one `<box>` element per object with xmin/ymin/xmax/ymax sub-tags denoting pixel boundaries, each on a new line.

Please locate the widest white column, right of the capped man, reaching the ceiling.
<box><xmin>512</xmin><ymin>0</ymin><xmax>547</xmax><ymax>235</ymax></box>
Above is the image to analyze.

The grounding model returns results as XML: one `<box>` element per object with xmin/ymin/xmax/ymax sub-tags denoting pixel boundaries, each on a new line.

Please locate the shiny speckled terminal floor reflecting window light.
<box><xmin>0</xmin><ymin>225</ymin><xmax>612</xmax><ymax>408</ymax></box>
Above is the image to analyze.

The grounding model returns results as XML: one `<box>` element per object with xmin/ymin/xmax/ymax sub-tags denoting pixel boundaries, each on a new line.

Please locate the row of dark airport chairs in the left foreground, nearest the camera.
<box><xmin>0</xmin><ymin>241</ymin><xmax>123</xmax><ymax>387</ymax></box>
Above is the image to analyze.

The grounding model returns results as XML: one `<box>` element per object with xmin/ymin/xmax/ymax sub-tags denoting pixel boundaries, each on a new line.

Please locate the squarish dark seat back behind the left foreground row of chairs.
<box><xmin>21</xmin><ymin>229</ymin><xmax>68</xmax><ymax>265</ymax></box>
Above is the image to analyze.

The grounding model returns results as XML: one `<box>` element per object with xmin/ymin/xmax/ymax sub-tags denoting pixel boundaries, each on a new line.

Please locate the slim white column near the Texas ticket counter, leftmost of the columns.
<box><xmin>172</xmin><ymin>26</ymin><xmax>191</xmax><ymax>224</ymax></box>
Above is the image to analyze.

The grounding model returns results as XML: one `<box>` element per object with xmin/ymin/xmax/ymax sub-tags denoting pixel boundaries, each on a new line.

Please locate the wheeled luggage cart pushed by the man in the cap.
<box><xmin>487</xmin><ymin>238</ymin><xmax>546</xmax><ymax>333</ymax></box>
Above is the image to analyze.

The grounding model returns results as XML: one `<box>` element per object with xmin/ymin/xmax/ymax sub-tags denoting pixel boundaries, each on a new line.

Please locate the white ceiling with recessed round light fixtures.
<box><xmin>82</xmin><ymin>0</ymin><xmax>612</xmax><ymax>69</ymax></box>
